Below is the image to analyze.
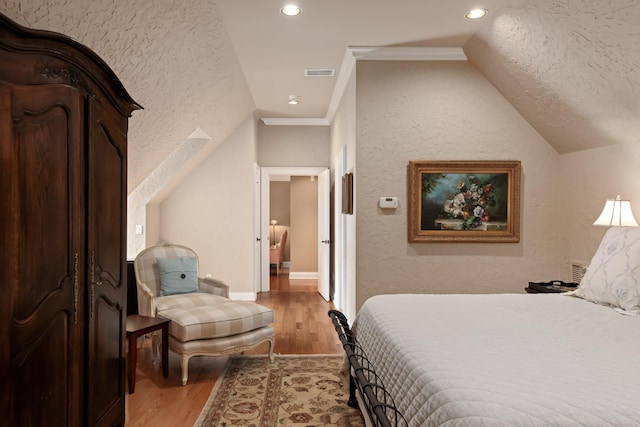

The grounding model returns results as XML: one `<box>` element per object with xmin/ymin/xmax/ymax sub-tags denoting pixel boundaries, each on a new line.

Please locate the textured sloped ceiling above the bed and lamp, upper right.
<box><xmin>464</xmin><ymin>0</ymin><xmax>640</xmax><ymax>154</ymax></box>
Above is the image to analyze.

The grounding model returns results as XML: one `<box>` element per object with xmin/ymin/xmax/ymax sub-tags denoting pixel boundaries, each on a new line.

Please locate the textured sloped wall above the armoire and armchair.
<box><xmin>0</xmin><ymin>0</ymin><xmax>254</xmax><ymax>191</ymax></box>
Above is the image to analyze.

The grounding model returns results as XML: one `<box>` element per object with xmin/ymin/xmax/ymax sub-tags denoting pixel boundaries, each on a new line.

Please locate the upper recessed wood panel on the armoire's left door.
<box><xmin>13</xmin><ymin>94</ymin><xmax>78</xmax><ymax>320</ymax></box>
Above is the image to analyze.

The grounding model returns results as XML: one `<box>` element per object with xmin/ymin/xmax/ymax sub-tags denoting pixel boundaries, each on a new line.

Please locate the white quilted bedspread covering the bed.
<box><xmin>354</xmin><ymin>294</ymin><xmax>640</xmax><ymax>427</ymax></box>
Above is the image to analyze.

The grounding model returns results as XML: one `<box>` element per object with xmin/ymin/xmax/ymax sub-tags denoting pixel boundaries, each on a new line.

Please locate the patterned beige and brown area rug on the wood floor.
<box><xmin>195</xmin><ymin>355</ymin><xmax>364</xmax><ymax>427</ymax></box>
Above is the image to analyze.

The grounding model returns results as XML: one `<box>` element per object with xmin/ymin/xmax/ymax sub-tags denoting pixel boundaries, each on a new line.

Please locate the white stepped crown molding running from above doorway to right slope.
<box><xmin>262</xmin><ymin>46</ymin><xmax>467</xmax><ymax>126</ymax></box>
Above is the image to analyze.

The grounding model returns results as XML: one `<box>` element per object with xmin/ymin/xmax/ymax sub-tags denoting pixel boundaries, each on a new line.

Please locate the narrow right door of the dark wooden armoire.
<box><xmin>87</xmin><ymin>93</ymin><xmax>127</xmax><ymax>425</ymax></box>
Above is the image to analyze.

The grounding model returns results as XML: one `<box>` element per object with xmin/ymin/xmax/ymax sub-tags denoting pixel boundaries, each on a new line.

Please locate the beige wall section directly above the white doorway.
<box><xmin>258</xmin><ymin>121</ymin><xmax>329</xmax><ymax>167</ymax></box>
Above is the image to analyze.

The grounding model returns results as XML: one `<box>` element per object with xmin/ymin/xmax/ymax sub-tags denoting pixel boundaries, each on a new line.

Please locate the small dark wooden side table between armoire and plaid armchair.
<box><xmin>127</xmin><ymin>314</ymin><xmax>170</xmax><ymax>394</ymax></box>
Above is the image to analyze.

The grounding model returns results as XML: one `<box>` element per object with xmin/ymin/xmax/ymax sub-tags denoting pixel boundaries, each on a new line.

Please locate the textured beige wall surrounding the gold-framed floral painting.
<box><xmin>355</xmin><ymin>61</ymin><xmax>566</xmax><ymax>307</ymax></box>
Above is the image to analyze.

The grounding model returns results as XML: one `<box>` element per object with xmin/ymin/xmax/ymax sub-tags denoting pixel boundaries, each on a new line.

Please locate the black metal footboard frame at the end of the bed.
<box><xmin>329</xmin><ymin>310</ymin><xmax>408</xmax><ymax>427</ymax></box>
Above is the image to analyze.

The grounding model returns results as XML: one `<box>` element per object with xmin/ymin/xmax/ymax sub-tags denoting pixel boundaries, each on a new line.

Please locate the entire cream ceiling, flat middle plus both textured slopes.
<box><xmin>0</xmin><ymin>0</ymin><xmax>640</xmax><ymax>190</ymax></box>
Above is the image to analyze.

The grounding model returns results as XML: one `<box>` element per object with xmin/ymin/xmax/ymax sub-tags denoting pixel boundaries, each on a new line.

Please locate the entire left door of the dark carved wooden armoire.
<box><xmin>0</xmin><ymin>82</ymin><xmax>86</xmax><ymax>426</ymax></box>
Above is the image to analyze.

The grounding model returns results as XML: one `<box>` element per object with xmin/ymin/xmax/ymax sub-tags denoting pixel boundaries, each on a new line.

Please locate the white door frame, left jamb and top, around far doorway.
<box><xmin>254</xmin><ymin>166</ymin><xmax>329</xmax><ymax>292</ymax></box>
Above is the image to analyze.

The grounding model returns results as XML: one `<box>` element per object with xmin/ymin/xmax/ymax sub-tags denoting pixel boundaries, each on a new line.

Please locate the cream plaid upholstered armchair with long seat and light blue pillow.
<box><xmin>134</xmin><ymin>244</ymin><xmax>274</xmax><ymax>385</ymax></box>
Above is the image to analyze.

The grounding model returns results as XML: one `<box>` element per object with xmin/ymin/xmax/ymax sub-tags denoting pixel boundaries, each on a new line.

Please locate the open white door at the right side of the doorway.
<box><xmin>318</xmin><ymin>169</ymin><xmax>331</xmax><ymax>301</ymax></box>
